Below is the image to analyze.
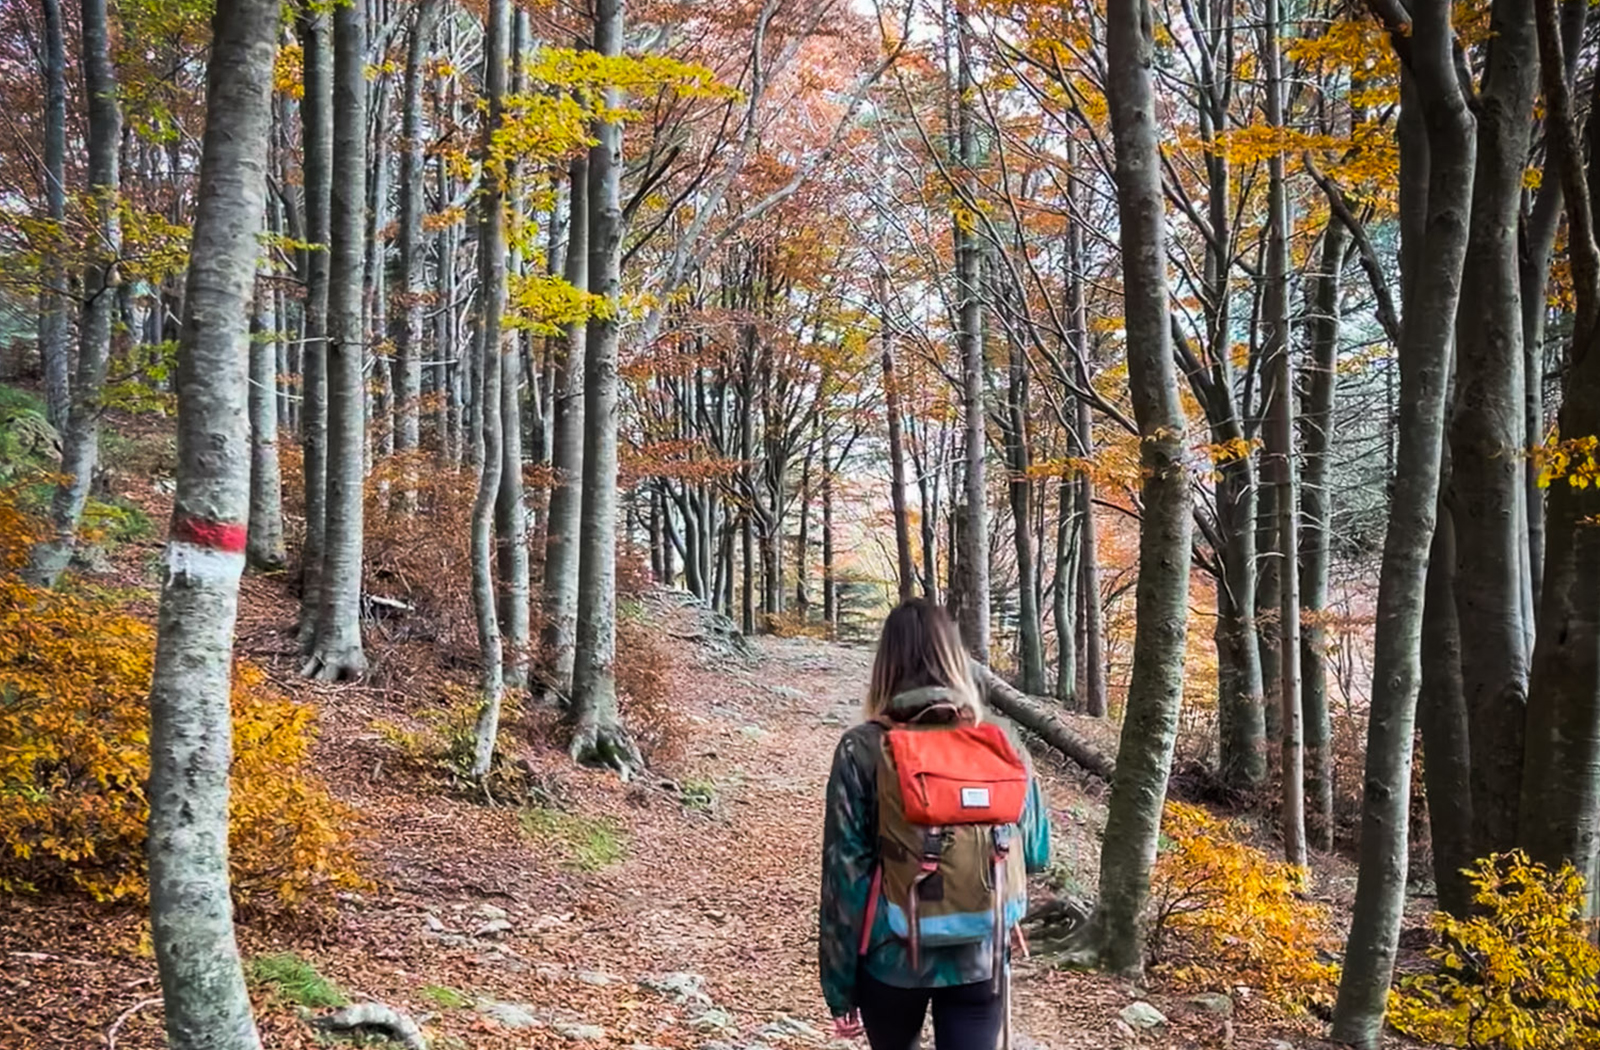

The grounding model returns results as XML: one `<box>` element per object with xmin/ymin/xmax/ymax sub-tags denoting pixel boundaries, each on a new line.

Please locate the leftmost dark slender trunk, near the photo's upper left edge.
<box><xmin>38</xmin><ymin>0</ymin><xmax>72</xmax><ymax>429</ymax></box>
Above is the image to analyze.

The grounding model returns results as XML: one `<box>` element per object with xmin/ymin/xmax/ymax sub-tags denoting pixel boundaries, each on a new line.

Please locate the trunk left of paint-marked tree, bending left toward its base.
<box><xmin>27</xmin><ymin>0</ymin><xmax>122</xmax><ymax>587</ymax></box>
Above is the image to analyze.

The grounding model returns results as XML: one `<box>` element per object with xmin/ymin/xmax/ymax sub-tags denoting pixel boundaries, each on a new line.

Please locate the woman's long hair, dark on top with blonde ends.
<box><xmin>864</xmin><ymin>599</ymin><xmax>984</xmax><ymax>722</ymax></box>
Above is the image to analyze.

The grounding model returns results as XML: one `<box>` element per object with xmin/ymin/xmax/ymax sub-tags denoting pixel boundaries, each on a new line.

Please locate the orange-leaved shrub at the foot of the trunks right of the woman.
<box><xmin>1150</xmin><ymin>802</ymin><xmax>1338</xmax><ymax>1007</ymax></box>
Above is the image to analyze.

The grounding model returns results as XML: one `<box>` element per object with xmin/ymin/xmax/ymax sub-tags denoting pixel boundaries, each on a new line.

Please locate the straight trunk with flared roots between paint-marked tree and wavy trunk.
<box><xmin>304</xmin><ymin>3</ymin><xmax>366</xmax><ymax>682</ymax></box>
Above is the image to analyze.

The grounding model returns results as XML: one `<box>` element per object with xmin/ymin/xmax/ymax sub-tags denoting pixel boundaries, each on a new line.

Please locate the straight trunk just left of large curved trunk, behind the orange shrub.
<box><xmin>1301</xmin><ymin>221</ymin><xmax>1349</xmax><ymax>853</ymax></box>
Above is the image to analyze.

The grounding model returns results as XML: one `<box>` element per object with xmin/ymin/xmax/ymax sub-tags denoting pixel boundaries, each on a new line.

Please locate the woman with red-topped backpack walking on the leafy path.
<box><xmin>818</xmin><ymin>599</ymin><xmax>1050</xmax><ymax>1050</ymax></box>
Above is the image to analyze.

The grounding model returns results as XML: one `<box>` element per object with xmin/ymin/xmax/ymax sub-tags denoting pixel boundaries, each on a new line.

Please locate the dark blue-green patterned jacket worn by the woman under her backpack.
<box><xmin>818</xmin><ymin>690</ymin><xmax>1050</xmax><ymax>1016</ymax></box>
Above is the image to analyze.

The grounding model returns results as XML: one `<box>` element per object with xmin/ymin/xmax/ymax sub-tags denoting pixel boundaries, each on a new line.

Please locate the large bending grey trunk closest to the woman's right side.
<box><xmin>1088</xmin><ymin>0</ymin><xmax>1194</xmax><ymax>975</ymax></box>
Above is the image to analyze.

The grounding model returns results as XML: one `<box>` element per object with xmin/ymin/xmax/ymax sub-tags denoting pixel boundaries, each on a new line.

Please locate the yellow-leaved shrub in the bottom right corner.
<box><xmin>1389</xmin><ymin>850</ymin><xmax>1600</xmax><ymax>1050</ymax></box>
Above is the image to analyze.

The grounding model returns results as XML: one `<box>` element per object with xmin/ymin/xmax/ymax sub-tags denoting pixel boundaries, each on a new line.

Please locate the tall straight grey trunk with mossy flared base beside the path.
<box><xmin>571</xmin><ymin>0</ymin><xmax>638</xmax><ymax>776</ymax></box>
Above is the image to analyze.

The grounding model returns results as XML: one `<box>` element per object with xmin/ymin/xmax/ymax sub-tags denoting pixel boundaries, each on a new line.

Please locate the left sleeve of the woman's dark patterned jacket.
<box><xmin>818</xmin><ymin>727</ymin><xmax>877</xmax><ymax>1016</ymax></box>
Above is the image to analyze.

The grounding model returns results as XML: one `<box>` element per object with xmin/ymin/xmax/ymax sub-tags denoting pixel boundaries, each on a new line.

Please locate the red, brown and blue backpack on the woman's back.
<box><xmin>861</xmin><ymin>704</ymin><xmax>1029</xmax><ymax>980</ymax></box>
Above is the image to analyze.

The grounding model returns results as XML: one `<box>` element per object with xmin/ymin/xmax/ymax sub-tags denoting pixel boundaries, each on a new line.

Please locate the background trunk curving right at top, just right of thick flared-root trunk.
<box><xmin>395</xmin><ymin>0</ymin><xmax>435</xmax><ymax>514</ymax></box>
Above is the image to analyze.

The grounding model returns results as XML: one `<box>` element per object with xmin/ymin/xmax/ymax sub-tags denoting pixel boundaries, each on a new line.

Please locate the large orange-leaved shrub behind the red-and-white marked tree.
<box><xmin>0</xmin><ymin>488</ymin><xmax>360</xmax><ymax>909</ymax></box>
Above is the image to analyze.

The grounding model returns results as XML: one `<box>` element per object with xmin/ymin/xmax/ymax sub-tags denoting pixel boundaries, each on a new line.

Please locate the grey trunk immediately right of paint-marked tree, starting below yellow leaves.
<box><xmin>245</xmin><ymin>249</ymin><xmax>288</xmax><ymax>573</ymax></box>
